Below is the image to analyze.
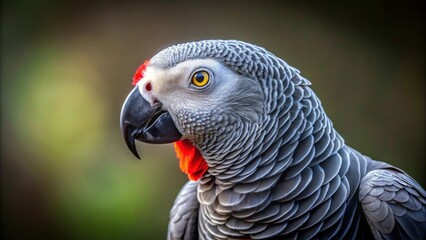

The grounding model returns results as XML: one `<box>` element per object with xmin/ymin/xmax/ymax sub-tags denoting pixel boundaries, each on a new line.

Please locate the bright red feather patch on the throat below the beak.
<box><xmin>174</xmin><ymin>140</ymin><xmax>209</xmax><ymax>181</ymax></box>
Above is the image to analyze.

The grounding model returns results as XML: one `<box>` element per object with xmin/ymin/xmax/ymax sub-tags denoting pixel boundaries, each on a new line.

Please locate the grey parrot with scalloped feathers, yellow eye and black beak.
<box><xmin>120</xmin><ymin>40</ymin><xmax>426</xmax><ymax>240</ymax></box>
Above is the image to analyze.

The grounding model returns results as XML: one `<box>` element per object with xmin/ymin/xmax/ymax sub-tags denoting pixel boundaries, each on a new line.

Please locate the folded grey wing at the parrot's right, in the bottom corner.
<box><xmin>359</xmin><ymin>167</ymin><xmax>426</xmax><ymax>239</ymax></box>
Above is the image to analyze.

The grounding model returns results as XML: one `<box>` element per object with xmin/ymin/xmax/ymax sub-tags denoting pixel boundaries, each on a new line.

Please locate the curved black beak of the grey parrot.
<box><xmin>120</xmin><ymin>87</ymin><xmax>182</xmax><ymax>159</ymax></box>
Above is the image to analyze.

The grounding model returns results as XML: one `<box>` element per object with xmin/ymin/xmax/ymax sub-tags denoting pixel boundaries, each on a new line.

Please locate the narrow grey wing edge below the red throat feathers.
<box><xmin>167</xmin><ymin>181</ymin><xmax>200</xmax><ymax>240</ymax></box>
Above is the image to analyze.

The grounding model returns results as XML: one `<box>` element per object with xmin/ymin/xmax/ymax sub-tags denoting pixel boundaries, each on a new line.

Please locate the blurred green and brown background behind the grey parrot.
<box><xmin>1</xmin><ymin>0</ymin><xmax>426</xmax><ymax>239</ymax></box>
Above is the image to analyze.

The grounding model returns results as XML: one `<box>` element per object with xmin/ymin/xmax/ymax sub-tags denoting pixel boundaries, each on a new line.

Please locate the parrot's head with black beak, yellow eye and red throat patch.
<box><xmin>120</xmin><ymin>40</ymin><xmax>302</xmax><ymax>180</ymax></box>
